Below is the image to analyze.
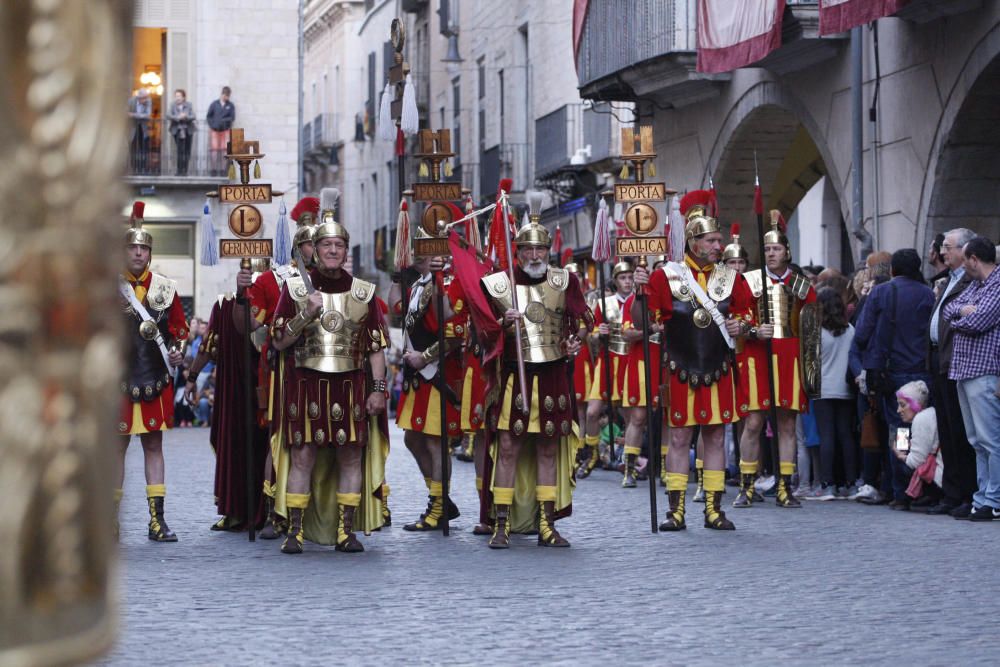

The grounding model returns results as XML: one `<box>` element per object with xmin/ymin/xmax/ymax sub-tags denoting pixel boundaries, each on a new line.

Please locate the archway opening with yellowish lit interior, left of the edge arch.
<box><xmin>703</xmin><ymin>81</ymin><xmax>852</xmax><ymax>268</ymax></box>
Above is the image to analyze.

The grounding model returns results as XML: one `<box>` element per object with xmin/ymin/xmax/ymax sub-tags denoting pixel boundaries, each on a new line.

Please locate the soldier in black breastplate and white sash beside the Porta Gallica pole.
<box><xmin>633</xmin><ymin>190</ymin><xmax>766</xmax><ymax>531</ymax></box>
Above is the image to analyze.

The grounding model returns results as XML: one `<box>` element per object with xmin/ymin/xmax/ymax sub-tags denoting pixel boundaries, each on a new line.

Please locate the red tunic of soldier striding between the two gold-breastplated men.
<box><xmin>396</xmin><ymin>274</ymin><xmax>469</xmax><ymax>438</ymax></box>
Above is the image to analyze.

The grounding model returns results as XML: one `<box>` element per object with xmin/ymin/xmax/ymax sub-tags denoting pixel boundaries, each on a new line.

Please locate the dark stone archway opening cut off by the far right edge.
<box><xmin>916</xmin><ymin>24</ymin><xmax>1000</xmax><ymax>249</ymax></box>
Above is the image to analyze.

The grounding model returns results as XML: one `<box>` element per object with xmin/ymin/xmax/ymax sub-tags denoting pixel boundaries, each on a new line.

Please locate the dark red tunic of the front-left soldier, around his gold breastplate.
<box><xmin>273</xmin><ymin>269</ymin><xmax>389</xmax><ymax>447</ymax></box>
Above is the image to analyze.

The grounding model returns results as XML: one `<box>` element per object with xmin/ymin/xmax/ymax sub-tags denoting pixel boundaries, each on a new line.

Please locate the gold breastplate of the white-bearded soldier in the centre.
<box><xmin>483</xmin><ymin>267</ymin><xmax>569</xmax><ymax>363</ymax></box>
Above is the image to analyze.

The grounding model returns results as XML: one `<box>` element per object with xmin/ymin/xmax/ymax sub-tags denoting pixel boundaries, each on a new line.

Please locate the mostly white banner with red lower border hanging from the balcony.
<box><xmin>698</xmin><ymin>0</ymin><xmax>785</xmax><ymax>73</ymax></box>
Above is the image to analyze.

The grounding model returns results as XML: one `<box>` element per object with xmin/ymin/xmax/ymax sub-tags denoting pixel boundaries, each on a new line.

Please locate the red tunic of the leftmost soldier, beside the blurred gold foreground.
<box><xmin>118</xmin><ymin>269</ymin><xmax>188</xmax><ymax>435</ymax></box>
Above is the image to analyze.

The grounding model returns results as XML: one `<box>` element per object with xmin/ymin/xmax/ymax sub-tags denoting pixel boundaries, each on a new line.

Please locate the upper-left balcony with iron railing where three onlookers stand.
<box><xmin>125</xmin><ymin>118</ymin><xmax>229</xmax><ymax>185</ymax></box>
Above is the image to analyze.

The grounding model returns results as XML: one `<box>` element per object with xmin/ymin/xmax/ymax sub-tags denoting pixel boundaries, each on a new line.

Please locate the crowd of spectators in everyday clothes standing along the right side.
<box><xmin>798</xmin><ymin>228</ymin><xmax>1000</xmax><ymax>521</ymax></box>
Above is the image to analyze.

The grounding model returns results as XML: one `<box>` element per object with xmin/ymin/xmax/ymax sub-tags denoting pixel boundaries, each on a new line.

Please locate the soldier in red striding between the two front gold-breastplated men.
<box><xmin>390</xmin><ymin>243</ymin><xmax>468</xmax><ymax>531</ymax></box>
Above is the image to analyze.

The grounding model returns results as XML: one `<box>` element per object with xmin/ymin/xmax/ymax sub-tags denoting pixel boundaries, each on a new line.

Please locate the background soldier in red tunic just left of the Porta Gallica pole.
<box><xmin>584</xmin><ymin>262</ymin><xmax>642</xmax><ymax>474</ymax></box>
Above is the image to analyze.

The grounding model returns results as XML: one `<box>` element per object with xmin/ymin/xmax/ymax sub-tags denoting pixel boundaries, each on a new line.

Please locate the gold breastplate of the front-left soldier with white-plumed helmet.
<box><xmin>289</xmin><ymin>278</ymin><xmax>377</xmax><ymax>373</ymax></box>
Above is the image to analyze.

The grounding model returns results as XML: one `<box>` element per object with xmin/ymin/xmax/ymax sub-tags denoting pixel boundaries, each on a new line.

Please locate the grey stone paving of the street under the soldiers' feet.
<box><xmin>98</xmin><ymin>429</ymin><xmax>1000</xmax><ymax>665</ymax></box>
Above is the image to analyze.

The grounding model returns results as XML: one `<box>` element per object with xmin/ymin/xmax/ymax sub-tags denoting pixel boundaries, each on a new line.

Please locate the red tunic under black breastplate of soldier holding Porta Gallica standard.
<box><xmin>646</xmin><ymin>257</ymin><xmax>753</xmax><ymax>427</ymax></box>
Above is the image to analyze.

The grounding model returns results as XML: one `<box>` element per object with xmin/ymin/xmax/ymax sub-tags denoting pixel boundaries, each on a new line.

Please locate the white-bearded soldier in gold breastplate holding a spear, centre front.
<box><xmin>482</xmin><ymin>195</ymin><xmax>592</xmax><ymax>549</ymax></box>
